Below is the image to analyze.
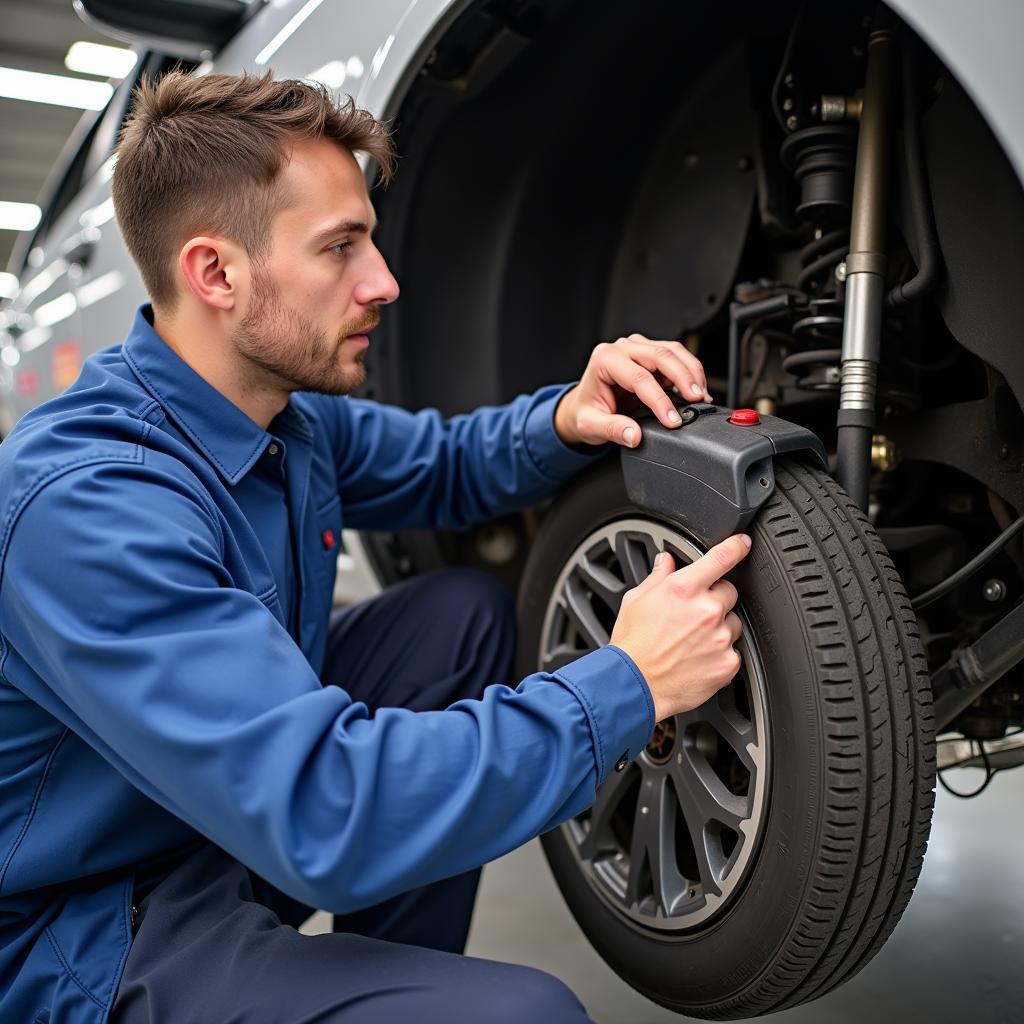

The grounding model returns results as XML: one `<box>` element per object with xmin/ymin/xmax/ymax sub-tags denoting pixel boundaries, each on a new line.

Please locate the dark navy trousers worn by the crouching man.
<box><xmin>111</xmin><ymin>569</ymin><xmax>589</xmax><ymax>1024</ymax></box>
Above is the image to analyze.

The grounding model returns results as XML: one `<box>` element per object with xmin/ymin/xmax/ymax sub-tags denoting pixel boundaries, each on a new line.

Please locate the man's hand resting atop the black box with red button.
<box><xmin>555</xmin><ymin>334</ymin><xmax>712</xmax><ymax>447</ymax></box>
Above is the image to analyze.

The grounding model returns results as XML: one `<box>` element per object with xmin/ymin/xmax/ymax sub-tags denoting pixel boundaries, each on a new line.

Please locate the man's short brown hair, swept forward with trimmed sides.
<box><xmin>113</xmin><ymin>71</ymin><xmax>394</xmax><ymax>312</ymax></box>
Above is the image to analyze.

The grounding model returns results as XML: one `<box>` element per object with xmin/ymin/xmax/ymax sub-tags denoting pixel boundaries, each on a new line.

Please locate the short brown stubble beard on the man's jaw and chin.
<box><xmin>231</xmin><ymin>270</ymin><xmax>379</xmax><ymax>395</ymax></box>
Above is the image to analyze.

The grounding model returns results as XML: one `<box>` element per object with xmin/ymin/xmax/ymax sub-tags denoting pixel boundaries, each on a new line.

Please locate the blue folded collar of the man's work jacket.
<box><xmin>122</xmin><ymin>303</ymin><xmax>280</xmax><ymax>485</ymax></box>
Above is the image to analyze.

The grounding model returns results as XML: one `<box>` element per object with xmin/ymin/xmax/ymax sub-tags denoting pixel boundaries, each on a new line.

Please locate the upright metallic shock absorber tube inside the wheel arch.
<box><xmin>837</xmin><ymin>14</ymin><xmax>897</xmax><ymax>509</ymax></box>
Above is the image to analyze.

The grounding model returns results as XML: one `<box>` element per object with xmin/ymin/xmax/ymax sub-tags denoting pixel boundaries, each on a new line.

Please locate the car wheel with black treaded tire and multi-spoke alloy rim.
<box><xmin>519</xmin><ymin>458</ymin><xmax>935</xmax><ymax>1020</ymax></box>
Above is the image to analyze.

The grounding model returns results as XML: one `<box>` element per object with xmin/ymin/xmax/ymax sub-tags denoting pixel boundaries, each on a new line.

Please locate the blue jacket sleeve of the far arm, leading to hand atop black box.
<box><xmin>323</xmin><ymin>385</ymin><xmax>609</xmax><ymax>529</ymax></box>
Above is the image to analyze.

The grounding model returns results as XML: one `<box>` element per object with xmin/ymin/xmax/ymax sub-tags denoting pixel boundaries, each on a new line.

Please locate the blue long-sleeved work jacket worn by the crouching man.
<box><xmin>0</xmin><ymin>306</ymin><xmax>654</xmax><ymax>1024</ymax></box>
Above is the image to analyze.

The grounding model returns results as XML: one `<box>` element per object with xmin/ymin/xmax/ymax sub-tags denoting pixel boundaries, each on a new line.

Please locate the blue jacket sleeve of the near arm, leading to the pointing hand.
<box><xmin>0</xmin><ymin>453</ymin><xmax>653</xmax><ymax>912</ymax></box>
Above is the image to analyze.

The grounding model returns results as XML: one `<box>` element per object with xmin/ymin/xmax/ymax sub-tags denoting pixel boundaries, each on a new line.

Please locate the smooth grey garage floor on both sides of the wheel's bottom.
<box><xmin>468</xmin><ymin>767</ymin><xmax>1024</xmax><ymax>1024</ymax></box>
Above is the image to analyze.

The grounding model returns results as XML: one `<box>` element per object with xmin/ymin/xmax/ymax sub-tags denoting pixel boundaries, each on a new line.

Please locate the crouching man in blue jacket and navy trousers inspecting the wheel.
<box><xmin>0</xmin><ymin>72</ymin><xmax>750</xmax><ymax>1024</ymax></box>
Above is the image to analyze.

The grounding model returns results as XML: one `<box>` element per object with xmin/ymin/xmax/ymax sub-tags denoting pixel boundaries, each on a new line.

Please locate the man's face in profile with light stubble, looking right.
<box><xmin>231</xmin><ymin>140</ymin><xmax>398</xmax><ymax>394</ymax></box>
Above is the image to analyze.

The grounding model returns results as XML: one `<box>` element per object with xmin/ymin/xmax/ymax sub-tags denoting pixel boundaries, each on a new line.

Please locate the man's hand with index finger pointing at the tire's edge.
<box><xmin>610</xmin><ymin>534</ymin><xmax>750</xmax><ymax>722</ymax></box>
